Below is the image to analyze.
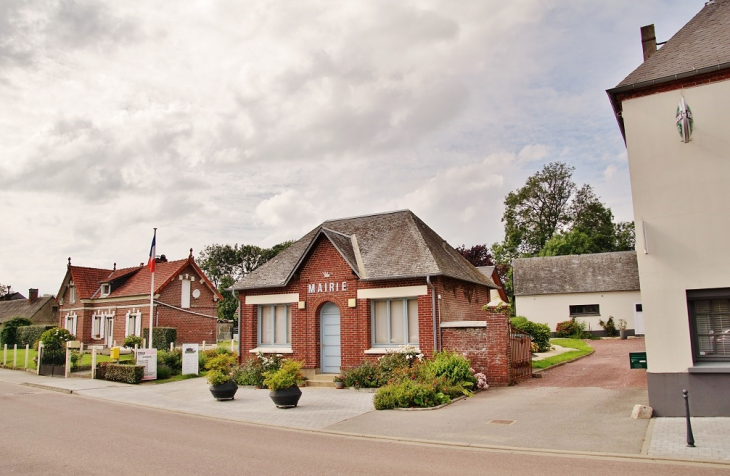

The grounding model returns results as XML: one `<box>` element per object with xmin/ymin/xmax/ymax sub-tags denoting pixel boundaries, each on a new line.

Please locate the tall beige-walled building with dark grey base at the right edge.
<box><xmin>607</xmin><ymin>0</ymin><xmax>730</xmax><ymax>417</ymax></box>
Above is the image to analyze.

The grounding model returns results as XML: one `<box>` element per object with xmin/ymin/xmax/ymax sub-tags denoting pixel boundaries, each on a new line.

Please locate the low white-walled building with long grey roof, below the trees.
<box><xmin>512</xmin><ymin>251</ymin><xmax>644</xmax><ymax>336</ymax></box>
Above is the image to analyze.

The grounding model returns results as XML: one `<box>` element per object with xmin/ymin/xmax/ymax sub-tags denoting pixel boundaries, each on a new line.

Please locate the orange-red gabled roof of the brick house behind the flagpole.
<box><xmin>59</xmin><ymin>255</ymin><xmax>223</xmax><ymax>299</ymax></box>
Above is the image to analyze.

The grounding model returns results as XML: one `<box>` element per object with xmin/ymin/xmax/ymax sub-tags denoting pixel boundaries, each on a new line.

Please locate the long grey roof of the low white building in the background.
<box><xmin>512</xmin><ymin>251</ymin><xmax>640</xmax><ymax>296</ymax></box>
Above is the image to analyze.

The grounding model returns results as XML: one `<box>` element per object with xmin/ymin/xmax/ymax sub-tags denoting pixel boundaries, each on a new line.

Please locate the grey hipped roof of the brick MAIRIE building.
<box><xmin>232</xmin><ymin>210</ymin><xmax>497</xmax><ymax>290</ymax></box>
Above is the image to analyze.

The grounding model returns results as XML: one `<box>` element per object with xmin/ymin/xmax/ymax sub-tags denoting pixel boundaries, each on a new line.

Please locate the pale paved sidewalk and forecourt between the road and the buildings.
<box><xmin>0</xmin><ymin>369</ymin><xmax>730</xmax><ymax>462</ymax></box>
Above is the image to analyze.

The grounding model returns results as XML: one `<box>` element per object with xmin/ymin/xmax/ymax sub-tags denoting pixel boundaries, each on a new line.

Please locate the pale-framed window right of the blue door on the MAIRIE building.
<box><xmin>370</xmin><ymin>298</ymin><xmax>418</xmax><ymax>347</ymax></box>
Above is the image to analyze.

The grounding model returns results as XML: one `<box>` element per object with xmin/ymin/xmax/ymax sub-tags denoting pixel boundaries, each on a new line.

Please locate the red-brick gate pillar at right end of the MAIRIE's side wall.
<box><xmin>486</xmin><ymin>306</ymin><xmax>511</xmax><ymax>387</ymax></box>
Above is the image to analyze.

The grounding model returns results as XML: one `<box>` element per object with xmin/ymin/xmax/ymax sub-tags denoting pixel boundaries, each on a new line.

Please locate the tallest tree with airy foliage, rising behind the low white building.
<box><xmin>502</xmin><ymin>162</ymin><xmax>575</xmax><ymax>256</ymax></box>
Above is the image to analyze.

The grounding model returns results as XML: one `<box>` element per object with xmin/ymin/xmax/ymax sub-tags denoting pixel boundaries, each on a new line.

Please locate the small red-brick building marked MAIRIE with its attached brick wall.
<box><xmin>232</xmin><ymin>210</ymin><xmax>511</xmax><ymax>385</ymax></box>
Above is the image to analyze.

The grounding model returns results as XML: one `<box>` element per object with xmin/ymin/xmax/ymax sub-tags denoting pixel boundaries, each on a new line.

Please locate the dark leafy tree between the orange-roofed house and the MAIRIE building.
<box><xmin>198</xmin><ymin>241</ymin><xmax>294</xmax><ymax>320</ymax></box>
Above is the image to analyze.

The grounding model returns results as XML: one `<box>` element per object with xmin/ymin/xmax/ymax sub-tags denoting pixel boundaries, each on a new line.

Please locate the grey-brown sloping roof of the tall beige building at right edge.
<box><xmin>617</xmin><ymin>0</ymin><xmax>730</xmax><ymax>87</ymax></box>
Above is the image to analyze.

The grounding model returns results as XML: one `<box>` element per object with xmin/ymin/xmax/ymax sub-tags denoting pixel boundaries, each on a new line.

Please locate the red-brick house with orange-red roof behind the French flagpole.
<box><xmin>57</xmin><ymin>249</ymin><xmax>222</xmax><ymax>347</ymax></box>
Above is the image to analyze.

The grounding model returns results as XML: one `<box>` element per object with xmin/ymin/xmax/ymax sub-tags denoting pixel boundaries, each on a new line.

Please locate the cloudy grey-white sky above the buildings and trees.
<box><xmin>0</xmin><ymin>0</ymin><xmax>704</xmax><ymax>294</ymax></box>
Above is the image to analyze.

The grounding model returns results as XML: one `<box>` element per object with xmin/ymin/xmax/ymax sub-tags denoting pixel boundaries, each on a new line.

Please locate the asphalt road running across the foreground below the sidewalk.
<box><xmin>0</xmin><ymin>383</ymin><xmax>730</xmax><ymax>476</ymax></box>
